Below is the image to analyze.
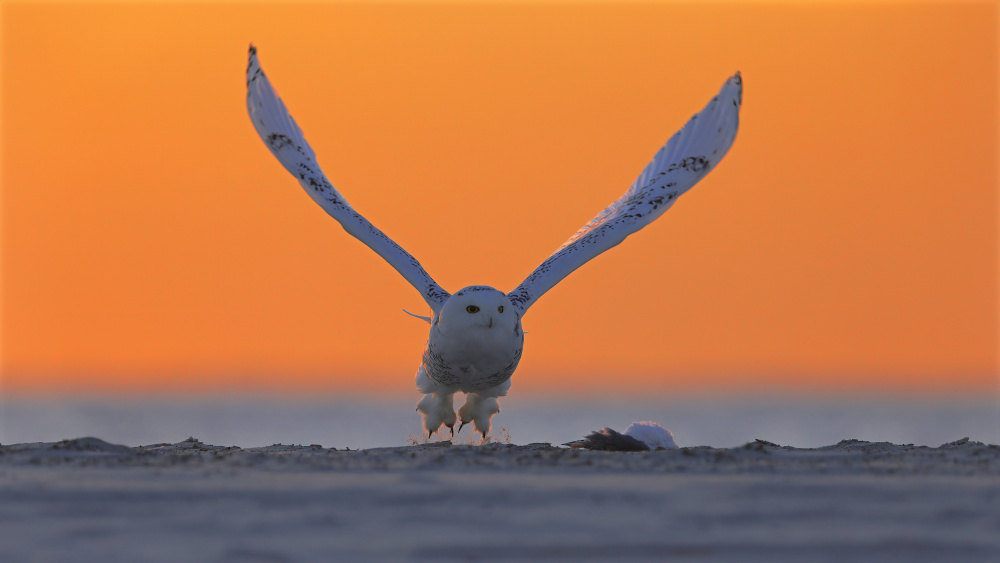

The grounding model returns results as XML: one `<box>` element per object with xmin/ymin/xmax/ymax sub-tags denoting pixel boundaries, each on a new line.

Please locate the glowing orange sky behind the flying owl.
<box><xmin>2</xmin><ymin>2</ymin><xmax>1000</xmax><ymax>393</ymax></box>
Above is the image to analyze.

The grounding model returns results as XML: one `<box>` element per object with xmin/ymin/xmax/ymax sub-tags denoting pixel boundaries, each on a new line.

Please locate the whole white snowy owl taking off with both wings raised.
<box><xmin>246</xmin><ymin>45</ymin><xmax>743</xmax><ymax>439</ymax></box>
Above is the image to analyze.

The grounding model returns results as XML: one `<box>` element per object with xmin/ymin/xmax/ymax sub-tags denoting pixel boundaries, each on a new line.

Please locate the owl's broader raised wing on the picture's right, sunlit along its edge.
<box><xmin>507</xmin><ymin>73</ymin><xmax>743</xmax><ymax>314</ymax></box>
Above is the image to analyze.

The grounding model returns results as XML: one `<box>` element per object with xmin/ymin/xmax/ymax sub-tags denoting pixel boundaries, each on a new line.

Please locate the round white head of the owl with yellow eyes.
<box><xmin>437</xmin><ymin>285</ymin><xmax>518</xmax><ymax>331</ymax></box>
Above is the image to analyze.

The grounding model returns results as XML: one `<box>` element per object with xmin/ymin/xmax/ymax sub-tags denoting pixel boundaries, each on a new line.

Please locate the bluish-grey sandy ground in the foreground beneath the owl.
<box><xmin>0</xmin><ymin>438</ymin><xmax>1000</xmax><ymax>563</ymax></box>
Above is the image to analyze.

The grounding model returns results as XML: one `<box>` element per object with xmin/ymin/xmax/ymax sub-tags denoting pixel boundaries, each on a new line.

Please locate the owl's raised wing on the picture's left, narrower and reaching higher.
<box><xmin>247</xmin><ymin>44</ymin><xmax>449</xmax><ymax>313</ymax></box>
